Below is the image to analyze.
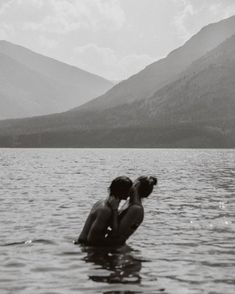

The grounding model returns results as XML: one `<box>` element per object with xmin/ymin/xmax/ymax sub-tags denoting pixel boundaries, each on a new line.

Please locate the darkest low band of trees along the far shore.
<box><xmin>0</xmin><ymin>122</ymin><xmax>235</xmax><ymax>148</ymax></box>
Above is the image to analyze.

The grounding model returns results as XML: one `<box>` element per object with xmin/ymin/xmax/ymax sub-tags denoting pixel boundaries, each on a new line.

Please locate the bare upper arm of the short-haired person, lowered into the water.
<box><xmin>87</xmin><ymin>209</ymin><xmax>111</xmax><ymax>245</ymax></box>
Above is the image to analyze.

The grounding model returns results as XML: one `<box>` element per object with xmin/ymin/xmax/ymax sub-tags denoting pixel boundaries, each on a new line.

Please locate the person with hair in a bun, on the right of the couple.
<box><xmin>106</xmin><ymin>176</ymin><xmax>157</xmax><ymax>246</ymax></box>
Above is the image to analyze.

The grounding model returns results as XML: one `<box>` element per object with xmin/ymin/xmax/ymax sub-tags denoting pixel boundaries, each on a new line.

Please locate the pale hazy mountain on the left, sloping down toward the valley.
<box><xmin>0</xmin><ymin>41</ymin><xmax>113</xmax><ymax>119</ymax></box>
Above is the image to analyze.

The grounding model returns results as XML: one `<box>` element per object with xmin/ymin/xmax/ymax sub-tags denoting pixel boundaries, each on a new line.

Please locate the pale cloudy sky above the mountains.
<box><xmin>0</xmin><ymin>0</ymin><xmax>235</xmax><ymax>81</ymax></box>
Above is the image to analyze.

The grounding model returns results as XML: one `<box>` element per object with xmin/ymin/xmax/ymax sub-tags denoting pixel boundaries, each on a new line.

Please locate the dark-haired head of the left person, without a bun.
<box><xmin>109</xmin><ymin>176</ymin><xmax>133</xmax><ymax>200</ymax></box>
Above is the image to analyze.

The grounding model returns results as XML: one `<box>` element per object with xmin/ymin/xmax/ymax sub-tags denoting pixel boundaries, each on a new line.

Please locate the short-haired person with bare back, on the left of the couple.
<box><xmin>75</xmin><ymin>176</ymin><xmax>133</xmax><ymax>246</ymax></box>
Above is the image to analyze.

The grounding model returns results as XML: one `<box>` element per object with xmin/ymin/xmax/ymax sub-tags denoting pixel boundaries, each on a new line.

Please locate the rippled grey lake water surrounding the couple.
<box><xmin>0</xmin><ymin>149</ymin><xmax>235</xmax><ymax>294</ymax></box>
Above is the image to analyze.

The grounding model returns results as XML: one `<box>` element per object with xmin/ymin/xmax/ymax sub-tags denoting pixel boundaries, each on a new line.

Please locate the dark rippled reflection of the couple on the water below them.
<box><xmin>82</xmin><ymin>246</ymin><xmax>142</xmax><ymax>284</ymax></box>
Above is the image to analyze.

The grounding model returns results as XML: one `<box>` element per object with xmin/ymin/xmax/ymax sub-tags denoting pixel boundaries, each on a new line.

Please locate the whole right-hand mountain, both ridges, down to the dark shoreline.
<box><xmin>0</xmin><ymin>17</ymin><xmax>235</xmax><ymax>147</ymax></box>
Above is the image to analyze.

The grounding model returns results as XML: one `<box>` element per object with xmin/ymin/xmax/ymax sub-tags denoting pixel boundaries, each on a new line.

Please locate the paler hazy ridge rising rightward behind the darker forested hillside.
<box><xmin>74</xmin><ymin>16</ymin><xmax>235</xmax><ymax>111</ymax></box>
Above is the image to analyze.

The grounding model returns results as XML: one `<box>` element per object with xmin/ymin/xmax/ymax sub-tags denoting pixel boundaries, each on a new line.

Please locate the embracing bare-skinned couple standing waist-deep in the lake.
<box><xmin>75</xmin><ymin>176</ymin><xmax>157</xmax><ymax>246</ymax></box>
